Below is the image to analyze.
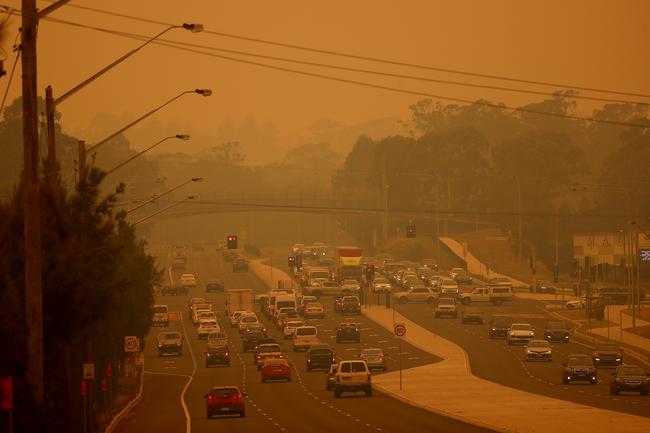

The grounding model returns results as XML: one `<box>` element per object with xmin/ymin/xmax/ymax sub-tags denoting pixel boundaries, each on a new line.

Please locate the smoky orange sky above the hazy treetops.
<box><xmin>4</xmin><ymin>0</ymin><xmax>650</xmax><ymax>164</ymax></box>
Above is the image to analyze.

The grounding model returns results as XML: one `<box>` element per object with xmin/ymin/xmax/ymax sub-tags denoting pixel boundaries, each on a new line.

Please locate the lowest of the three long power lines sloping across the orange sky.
<box><xmin>39</xmin><ymin>18</ymin><xmax>650</xmax><ymax>129</ymax></box>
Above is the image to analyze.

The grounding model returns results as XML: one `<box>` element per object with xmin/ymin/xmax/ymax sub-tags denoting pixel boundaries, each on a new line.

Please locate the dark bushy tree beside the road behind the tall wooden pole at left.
<box><xmin>0</xmin><ymin>168</ymin><xmax>158</xmax><ymax>432</ymax></box>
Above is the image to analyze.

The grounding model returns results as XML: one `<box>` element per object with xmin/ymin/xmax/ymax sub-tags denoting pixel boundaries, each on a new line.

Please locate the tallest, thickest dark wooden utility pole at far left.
<box><xmin>21</xmin><ymin>0</ymin><xmax>44</xmax><ymax>406</ymax></box>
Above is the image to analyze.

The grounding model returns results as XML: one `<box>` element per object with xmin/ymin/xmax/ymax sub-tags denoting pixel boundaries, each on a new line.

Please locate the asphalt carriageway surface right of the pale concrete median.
<box><xmin>264</xmin><ymin>248</ymin><xmax>650</xmax><ymax>417</ymax></box>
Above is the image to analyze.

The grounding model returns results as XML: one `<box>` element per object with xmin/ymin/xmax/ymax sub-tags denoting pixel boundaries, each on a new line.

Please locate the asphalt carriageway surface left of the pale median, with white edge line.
<box><xmin>119</xmin><ymin>248</ymin><xmax>496</xmax><ymax>433</ymax></box>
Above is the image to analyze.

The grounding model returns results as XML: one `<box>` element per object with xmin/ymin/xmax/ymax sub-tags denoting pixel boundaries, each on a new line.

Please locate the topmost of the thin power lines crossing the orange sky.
<box><xmin>36</xmin><ymin>0</ymin><xmax>650</xmax><ymax>98</ymax></box>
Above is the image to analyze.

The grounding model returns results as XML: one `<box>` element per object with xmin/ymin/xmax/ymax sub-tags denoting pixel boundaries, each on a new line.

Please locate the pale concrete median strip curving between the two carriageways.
<box><xmin>363</xmin><ymin>306</ymin><xmax>650</xmax><ymax>433</ymax></box>
